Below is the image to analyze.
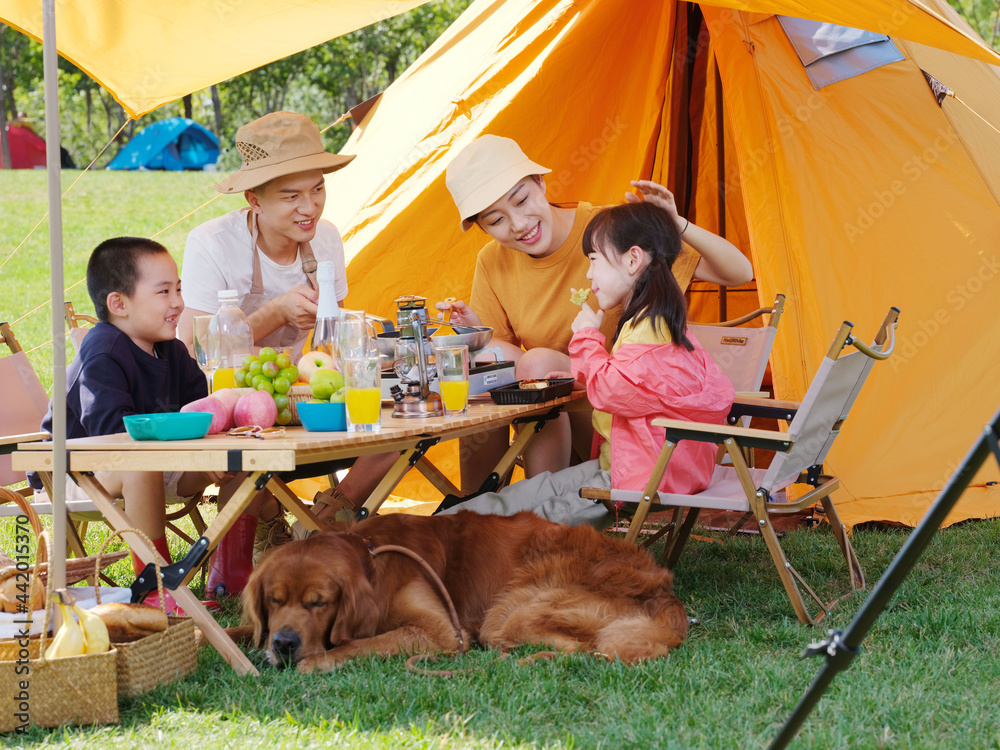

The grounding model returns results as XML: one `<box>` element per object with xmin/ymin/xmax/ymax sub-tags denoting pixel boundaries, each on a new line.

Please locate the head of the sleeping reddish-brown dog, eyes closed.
<box><xmin>243</xmin><ymin>532</ymin><xmax>379</xmax><ymax>666</ymax></box>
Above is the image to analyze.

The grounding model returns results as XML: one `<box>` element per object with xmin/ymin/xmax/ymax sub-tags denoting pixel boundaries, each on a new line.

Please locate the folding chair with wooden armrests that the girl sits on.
<box><xmin>580</xmin><ymin>307</ymin><xmax>899</xmax><ymax>624</ymax></box>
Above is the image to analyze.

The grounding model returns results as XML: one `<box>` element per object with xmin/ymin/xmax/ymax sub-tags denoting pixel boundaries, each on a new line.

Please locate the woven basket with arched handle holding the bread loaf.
<box><xmin>95</xmin><ymin>529</ymin><xmax>198</xmax><ymax>698</ymax></box>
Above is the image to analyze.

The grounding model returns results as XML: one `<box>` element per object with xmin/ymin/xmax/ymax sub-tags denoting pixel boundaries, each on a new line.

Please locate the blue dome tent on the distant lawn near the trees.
<box><xmin>108</xmin><ymin>117</ymin><xmax>219</xmax><ymax>172</ymax></box>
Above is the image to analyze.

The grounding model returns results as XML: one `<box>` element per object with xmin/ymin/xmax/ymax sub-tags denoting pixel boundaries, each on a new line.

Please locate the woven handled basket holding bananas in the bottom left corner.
<box><xmin>0</xmin><ymin>531</ymin><xmax>118</xmax><ymax>733</ymax></box>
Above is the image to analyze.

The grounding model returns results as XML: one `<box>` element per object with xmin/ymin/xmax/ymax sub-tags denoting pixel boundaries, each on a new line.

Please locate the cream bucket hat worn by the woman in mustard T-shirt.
<box><xmin>444</xmin><ymin>135</ymin><xmax>552</xmax><ymax>232</ymax></box>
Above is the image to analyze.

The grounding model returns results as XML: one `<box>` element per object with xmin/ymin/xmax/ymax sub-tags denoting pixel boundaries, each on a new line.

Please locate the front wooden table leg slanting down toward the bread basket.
<box><xmin>73</xmin><ymin>473</ymin><xmax>260</xmax><ymax>677</ymax></box>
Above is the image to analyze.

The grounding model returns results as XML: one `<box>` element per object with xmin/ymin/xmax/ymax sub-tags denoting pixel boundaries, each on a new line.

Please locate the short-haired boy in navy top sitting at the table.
<box><xmin>34</xmin><ymin>237</ymin><xmax>228</xmax><ymax>611</ymax></box>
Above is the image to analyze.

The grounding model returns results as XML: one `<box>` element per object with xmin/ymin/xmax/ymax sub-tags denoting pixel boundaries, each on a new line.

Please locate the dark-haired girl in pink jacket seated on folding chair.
<box><xmin>443</xmin><ymin>203</ymin><xmax>735</xmax><ymax>526</ymax></box>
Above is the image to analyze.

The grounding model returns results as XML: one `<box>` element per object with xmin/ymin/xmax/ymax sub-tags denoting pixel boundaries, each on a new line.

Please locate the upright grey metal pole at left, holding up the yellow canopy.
<box><xmin>42</xmin><ymin>0</ymin><xmax>66</xmax><ymax>604</ymax></box>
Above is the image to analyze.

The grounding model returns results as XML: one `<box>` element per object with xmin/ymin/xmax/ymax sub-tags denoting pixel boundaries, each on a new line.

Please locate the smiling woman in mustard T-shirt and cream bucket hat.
<box><xmin>438</xmin><ymin>135</ymin><xmax>753</xmax><ymax>492</ymax></box>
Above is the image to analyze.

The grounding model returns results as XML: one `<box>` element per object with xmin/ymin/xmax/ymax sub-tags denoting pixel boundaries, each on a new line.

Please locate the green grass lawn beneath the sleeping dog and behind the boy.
<box><xmin>0</xmin><ymin>171</ymin><xmax>1000</xmax><ymax>750</ymax></box>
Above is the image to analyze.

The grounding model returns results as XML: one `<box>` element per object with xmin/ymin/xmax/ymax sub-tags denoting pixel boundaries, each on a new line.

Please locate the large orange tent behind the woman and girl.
<box><xmin>327</xmin><ymin>0</ymin><xmax>1000</xmax><ymax>524</ymax></box>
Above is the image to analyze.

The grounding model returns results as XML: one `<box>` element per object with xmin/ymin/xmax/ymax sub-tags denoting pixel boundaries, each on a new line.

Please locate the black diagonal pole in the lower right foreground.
<box><xmin>770</xmin><ymin>411</ymin><xmax>1000</xmax><ymax>750</ymax></box>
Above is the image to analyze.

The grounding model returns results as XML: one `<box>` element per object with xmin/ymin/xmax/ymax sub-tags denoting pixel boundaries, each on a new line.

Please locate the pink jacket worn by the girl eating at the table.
<box><xmin>569</xmin><ymin>328</ymin><xmax>735</xmax><ymax>494</ymax></box>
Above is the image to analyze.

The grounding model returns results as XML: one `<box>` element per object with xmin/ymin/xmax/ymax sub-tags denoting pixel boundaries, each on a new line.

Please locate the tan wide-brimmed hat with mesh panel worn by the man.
<box><xmin>215</xmin><ymin>112</ymin><xmax>354</xmax><ymax>193</ymax></box>
